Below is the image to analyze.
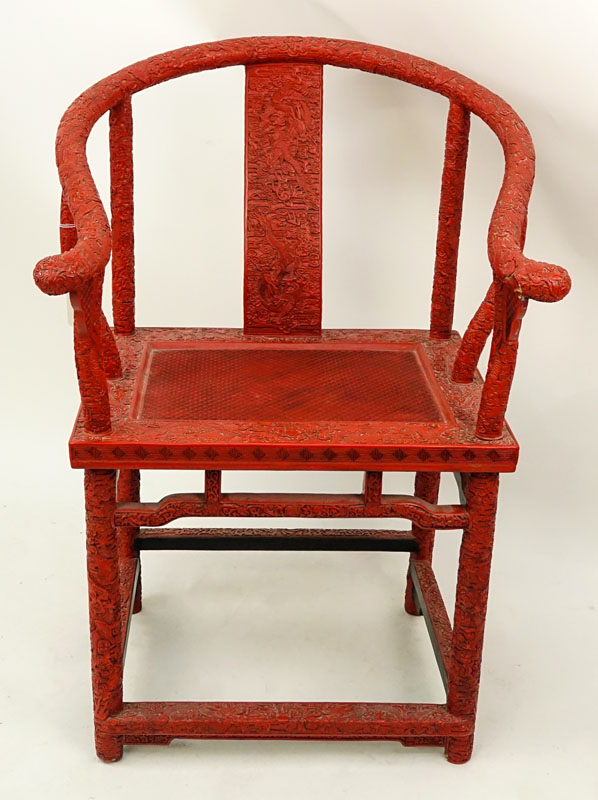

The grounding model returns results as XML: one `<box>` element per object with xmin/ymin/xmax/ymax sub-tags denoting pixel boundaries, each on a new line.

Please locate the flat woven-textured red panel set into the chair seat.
<box><xmin>137</xmin><ymin>347</ymin><xmax>442</xmax><ymax>422</ymax></box>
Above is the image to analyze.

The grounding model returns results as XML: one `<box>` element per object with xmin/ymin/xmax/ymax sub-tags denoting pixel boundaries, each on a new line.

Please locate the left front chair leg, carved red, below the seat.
<box><xmin>85</xmin><ymin>469</ymin><xmax>123</xmax><ymax>761</ymax></box>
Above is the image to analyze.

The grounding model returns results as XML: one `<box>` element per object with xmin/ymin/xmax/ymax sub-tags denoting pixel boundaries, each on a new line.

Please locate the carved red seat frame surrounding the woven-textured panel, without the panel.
<box><xmin>71</xmin><ymin>328</ymin><xmax>518</xmax><ymax>471</ymax></box>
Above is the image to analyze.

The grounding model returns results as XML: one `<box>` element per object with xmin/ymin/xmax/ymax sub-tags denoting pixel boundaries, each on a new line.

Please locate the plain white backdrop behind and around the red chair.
<box><xmin>0</xmin><ymin>0</ymin><xmax>598</xmax><ymax>798</ymax></box>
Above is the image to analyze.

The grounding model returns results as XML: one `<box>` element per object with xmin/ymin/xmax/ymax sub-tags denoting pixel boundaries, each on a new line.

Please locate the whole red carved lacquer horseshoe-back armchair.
<box><xmin>35</xmin><ymin>37</ymin><xmax>570</xmax><ymax>763</ymax></box>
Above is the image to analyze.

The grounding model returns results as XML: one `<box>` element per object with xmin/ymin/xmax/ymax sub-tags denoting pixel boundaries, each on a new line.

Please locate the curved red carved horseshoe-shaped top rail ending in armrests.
<box><xmin>36</xmin><ymin>37</ymin><xmax>570</xmax><ymax>301</ymax></box>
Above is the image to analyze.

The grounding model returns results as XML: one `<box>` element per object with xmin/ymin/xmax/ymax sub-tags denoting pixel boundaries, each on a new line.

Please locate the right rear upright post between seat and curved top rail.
<box><xmin>430</xmin><ymin>100</ymin><xmax>470</xmax><ymax>339</ymax></box>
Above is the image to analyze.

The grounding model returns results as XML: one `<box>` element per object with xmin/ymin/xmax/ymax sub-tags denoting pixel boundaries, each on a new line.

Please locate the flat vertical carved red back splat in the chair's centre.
<box><xmin>244</xmin><ymin>63</ymin><xmax>322</xmax><ymax>336</ymax></box>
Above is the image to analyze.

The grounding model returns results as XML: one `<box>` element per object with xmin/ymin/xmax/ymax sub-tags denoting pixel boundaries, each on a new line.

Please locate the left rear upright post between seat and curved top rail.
<box><xmin>109</xmin><ymin>95</ymin><xmax>135</xmax><ymax>334</ymax></box>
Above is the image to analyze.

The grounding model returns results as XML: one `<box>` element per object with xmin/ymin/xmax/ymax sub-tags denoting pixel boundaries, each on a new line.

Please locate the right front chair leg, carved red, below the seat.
<box><xmin>445</xmin><ymin>473</ymin><xmax>498</xmax><ymax>764</ymax></box>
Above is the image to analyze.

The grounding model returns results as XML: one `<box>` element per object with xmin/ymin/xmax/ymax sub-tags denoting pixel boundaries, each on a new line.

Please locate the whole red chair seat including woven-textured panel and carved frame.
<box><xmin>70</xmin><ymin>328</ymin><xmax>518</xmax><ymax>472</ymax></box>
